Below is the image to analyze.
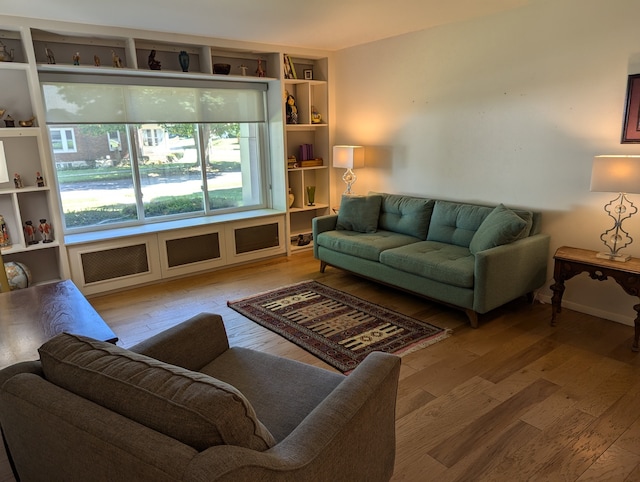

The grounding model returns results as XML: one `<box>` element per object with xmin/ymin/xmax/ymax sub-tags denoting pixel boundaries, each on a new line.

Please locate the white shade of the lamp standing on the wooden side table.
<box><xmin>591</xmin><ymin>156</ymin><xmax>640</xmax><ymax>194</ymax></box>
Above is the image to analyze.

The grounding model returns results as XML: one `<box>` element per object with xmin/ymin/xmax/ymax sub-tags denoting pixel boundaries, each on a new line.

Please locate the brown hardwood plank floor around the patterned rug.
<box><xmin>0</xmin><ymin>251</ymin><xmax>640</xmax><ymax>482</ymax></box>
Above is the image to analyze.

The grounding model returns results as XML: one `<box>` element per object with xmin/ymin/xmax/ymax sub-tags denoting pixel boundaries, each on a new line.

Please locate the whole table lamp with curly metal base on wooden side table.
<box><xmin>591</xmin><ymin>156</ymin><xmax>640</xmax><ymax>261</ymax></box>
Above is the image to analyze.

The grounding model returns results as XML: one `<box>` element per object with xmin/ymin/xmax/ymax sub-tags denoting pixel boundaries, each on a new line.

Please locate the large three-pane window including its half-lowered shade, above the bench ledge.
<box><xmin>43</xmin><ymin>74</ymin><xmax>268</xmax><ymax>232</ymax></box>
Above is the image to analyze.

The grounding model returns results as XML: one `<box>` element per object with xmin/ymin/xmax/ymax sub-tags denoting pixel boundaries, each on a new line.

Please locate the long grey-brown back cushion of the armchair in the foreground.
<box><xmin>38</xmin><ymin>333</ymin><xmax>276</xmax><ymax>451</ymax></box>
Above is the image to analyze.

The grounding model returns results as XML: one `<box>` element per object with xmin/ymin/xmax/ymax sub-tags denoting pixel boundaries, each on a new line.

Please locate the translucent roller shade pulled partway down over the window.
<box><xmin>41</xmin><ymin>74</ymin><xmax>267</xmax><ymax>124</ymax></box>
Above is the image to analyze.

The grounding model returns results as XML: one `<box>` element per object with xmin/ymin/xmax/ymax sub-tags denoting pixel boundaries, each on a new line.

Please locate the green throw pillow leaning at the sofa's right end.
<box><xmin>469</xmin><ymin>204</ymin><xmax>533</xmax><ymax>254</ymax></box>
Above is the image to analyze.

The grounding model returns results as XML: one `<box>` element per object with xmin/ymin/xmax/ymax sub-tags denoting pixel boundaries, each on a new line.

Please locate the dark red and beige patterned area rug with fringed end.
<box><xmin>227</xmin><ymin>281</ymin><xmax>450</xmax><ymax>373</ymax></box>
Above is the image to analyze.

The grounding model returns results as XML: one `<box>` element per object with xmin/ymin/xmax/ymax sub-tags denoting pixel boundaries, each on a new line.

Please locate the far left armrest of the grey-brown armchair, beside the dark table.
<box><xmin>129</xmin><ymin>313</ymin><xmax>229</xmax><ymax>371</ymax></box>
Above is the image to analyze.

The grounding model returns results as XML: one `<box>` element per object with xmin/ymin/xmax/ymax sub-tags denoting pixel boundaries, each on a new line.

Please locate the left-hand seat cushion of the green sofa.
<box><xmin>314</xmin><ymin>230</ymin><xmax>419</xmax><ymax>261</ymax></box>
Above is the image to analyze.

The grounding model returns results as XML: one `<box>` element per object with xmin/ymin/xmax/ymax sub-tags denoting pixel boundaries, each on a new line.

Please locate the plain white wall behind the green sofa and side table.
<box><xmin>333</xmin><ymin>0</ymin><xmax>640</xmax><ymax>324</ymax></box>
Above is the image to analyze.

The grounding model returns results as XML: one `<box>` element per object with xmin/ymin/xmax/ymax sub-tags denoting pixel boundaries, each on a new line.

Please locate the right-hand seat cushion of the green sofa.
<box><xmin>380</xmin><ymin>241</ymin><xmax>475</xmax><ymax>288</ymax></box>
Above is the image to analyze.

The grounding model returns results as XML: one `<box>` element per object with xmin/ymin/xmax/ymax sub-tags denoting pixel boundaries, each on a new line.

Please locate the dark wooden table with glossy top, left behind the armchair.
<box><xmin>0</xmin><ymin>280</ymin><xmax>118</xmax><ymax>368</ymax></box>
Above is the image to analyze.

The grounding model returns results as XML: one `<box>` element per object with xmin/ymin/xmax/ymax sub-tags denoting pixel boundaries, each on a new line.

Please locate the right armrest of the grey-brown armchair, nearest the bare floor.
<box><xmin>185</xmin><ymin>352</ymin><xmax>400</xmax><ymax>482</ymax></box>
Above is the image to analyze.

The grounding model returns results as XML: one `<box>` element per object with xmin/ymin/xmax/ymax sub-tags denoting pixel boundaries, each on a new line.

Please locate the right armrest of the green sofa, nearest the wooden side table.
<box><xmin>473</xmin><ymin>234</ymin><xmax>550</xmax><ymax>313</ymax></box>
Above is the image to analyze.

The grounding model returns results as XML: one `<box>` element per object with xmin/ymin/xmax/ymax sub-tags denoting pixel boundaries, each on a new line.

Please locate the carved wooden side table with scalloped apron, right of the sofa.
<box><xmin>551</xmin><ymin>246</ymin><xmax>640</xmax><ymax>351</ymax></box>
